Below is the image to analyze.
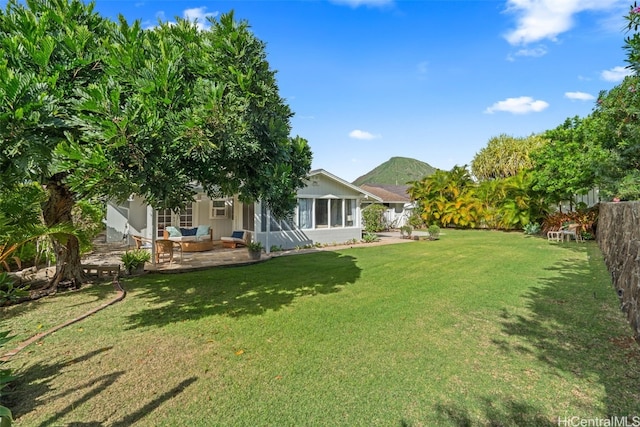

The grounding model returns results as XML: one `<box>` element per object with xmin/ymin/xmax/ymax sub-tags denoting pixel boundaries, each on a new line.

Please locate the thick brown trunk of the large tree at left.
<box><xmin>42</xmin><ymin>173</ymin><xmax>86</xmax><ymax>293</ymax></box>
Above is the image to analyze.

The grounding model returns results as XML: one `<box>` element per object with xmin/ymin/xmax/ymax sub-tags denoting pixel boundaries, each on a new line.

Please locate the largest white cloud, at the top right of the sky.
<box><xmin>505</xmin><ymin>0</ymin><xmax>628</xmax><ymax>45</ymax></box>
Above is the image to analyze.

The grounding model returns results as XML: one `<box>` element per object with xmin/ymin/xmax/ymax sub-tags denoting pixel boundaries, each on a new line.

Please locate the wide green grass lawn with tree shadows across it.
<box><xmin>0</xmin><ymin>230</ymin><xmax>640</xmax><ymax>426</ymax></box>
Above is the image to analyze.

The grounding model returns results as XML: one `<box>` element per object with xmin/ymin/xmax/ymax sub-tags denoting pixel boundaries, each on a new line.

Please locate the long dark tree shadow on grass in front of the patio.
<box><xmin>125</xmin><ymin>252</ymin><xmax>361</xmax><ymax>328</ymax></box>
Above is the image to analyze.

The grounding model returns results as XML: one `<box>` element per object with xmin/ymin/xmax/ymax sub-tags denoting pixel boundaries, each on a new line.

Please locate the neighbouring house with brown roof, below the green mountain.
<box><xmin>360</xmin><ymin>184</ymin><xmax>415</xmax><ymax>228</ymax></box>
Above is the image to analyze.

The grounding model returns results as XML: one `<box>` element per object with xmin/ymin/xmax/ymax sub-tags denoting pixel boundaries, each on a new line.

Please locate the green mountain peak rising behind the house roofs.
<box><xmin>353</xmin><ymin>157</ymin><xmax>437</xmax><ymax>186</ymax></box>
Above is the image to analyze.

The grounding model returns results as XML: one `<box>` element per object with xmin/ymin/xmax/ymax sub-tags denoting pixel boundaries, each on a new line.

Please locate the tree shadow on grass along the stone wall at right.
<box><xmin>494</xmin><ymin>245</ymin><xmax>640</xmax><ymax>416</ymax></box>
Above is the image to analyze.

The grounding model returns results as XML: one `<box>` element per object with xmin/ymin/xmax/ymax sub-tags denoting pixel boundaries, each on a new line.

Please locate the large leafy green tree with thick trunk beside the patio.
<box><xmin>0</xmin><ymin>0</ymin><xmax>311</xmax><ymax>292</ymax></box>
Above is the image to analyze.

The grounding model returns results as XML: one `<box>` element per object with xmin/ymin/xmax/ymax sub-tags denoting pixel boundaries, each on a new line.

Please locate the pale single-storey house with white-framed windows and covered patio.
<box><xmin>106</xmin><ymin>169</ymin><xmax>382</xmax><ymax>251</ymax></box>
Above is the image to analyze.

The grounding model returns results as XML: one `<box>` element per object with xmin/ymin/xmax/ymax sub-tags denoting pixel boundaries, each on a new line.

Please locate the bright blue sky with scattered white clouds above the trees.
<box><xmin>96</xmin><ymin>0</ymin><xmax>631</xmax><ymax>181</ymax></box>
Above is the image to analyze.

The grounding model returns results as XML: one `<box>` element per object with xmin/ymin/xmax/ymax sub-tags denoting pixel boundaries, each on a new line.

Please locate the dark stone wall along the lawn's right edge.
<box><xmin>597</xmin><ymin>202</ymin><xmax>640</xmax><ymax>342</ymax></box>
